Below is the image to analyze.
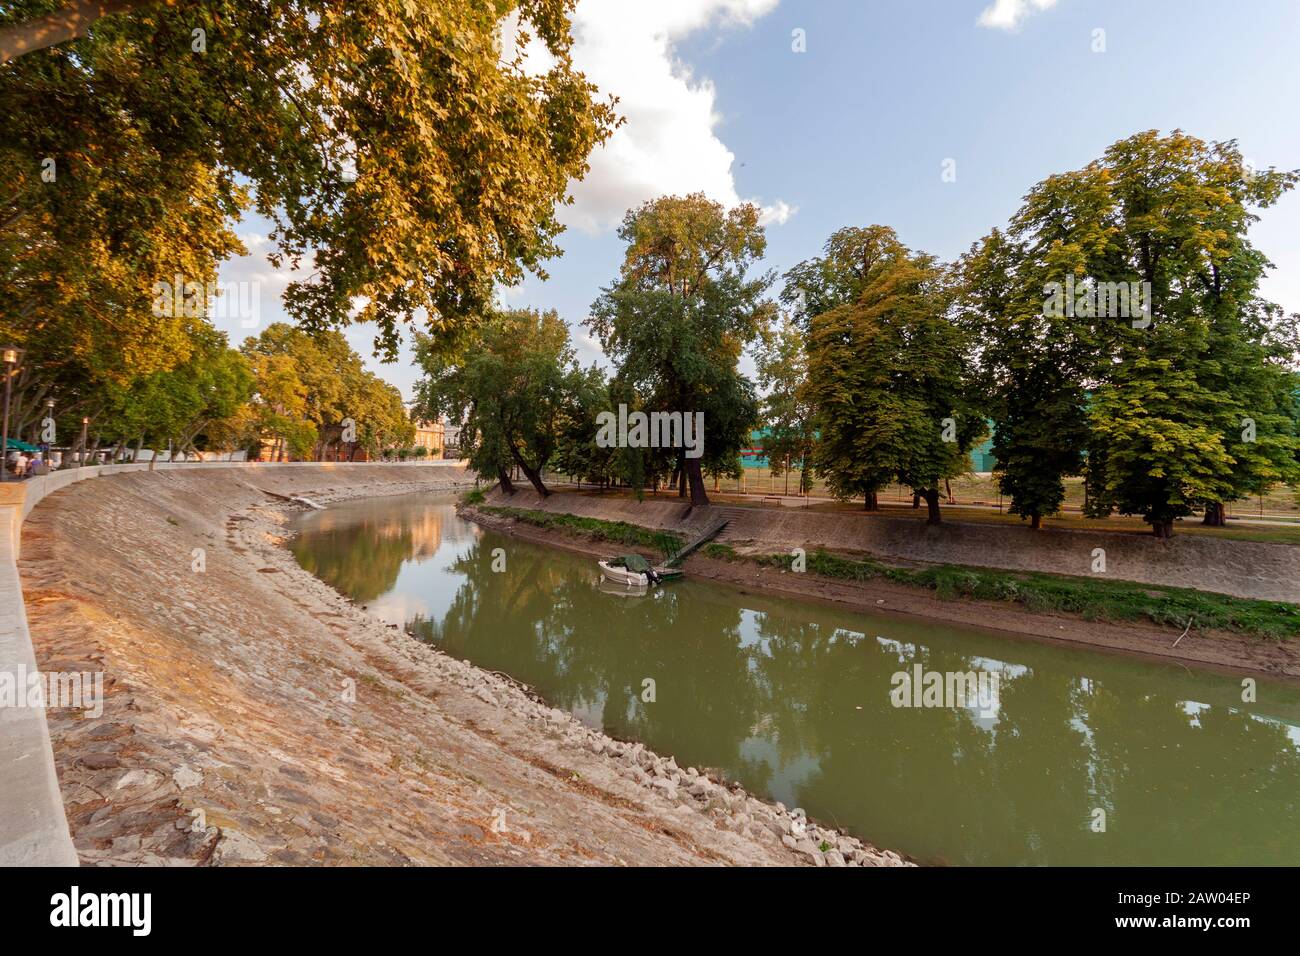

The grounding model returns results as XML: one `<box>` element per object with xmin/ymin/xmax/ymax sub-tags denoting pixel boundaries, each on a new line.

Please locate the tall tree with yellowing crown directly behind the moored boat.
<box><xmin>586</xmin><ymin>194</ymin><xmax>772</xmax><ymax>506</ymax></box>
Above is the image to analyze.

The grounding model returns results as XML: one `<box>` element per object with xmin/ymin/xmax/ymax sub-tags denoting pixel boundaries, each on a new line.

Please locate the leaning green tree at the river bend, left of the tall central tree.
<box><xmin>415</xmin><ymin>310</ymin><xmax>589</xmax><ymax>497</ymax></box>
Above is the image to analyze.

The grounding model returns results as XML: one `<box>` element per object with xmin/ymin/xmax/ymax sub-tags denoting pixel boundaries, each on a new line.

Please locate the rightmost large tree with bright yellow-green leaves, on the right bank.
<box><xmin>1017</xmin><ymin>131</ymin><xmax>1297</xmax><ymax>537</ymax></box>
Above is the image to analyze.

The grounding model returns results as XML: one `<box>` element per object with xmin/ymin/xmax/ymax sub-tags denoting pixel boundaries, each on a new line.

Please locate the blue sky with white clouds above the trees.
<box><xmin>217</xmin><ymin>0</ymin><xmax>1300</xmax><ymax>398</ymax></box>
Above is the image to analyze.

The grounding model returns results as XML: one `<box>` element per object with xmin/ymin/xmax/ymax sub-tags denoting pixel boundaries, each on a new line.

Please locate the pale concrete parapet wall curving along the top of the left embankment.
<box><xmin>0</xmin><ymin>462</ymin><xmax>463</xmax><ymax>866</ymax></box>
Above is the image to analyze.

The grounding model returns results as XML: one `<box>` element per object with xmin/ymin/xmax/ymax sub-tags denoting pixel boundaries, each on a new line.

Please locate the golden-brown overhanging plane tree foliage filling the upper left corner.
<box><xmin>0</xmin><ymin>0</ymin><xmax>616</xmax><ymax>423</ymax></box>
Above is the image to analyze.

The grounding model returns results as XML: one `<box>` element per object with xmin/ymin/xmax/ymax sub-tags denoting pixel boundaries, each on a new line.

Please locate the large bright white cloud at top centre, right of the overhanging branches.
<box><xmin>525</xmin><ymin>0</ymin><xmax>794</xmax><ymax>234</ymax></box>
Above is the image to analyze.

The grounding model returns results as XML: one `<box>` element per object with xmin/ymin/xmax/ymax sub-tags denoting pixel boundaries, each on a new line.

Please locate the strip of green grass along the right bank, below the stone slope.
<box><xmin>754</xmin><ymin>549</ymin><xmax>1300</xmax><ymax>640</ymax></box>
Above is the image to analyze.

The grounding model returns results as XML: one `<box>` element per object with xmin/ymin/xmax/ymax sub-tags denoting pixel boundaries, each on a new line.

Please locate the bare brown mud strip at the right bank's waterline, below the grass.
<box><xmin>462</xmin><ymin>493</ymin><xmax>1300</xmax><ymax>682</ymax></box>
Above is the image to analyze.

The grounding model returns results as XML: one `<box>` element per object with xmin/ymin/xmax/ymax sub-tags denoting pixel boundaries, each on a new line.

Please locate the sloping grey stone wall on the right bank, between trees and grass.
<box><xmin>490</xmin><ymin>490</ymin><xmax>1300</xmax><ymax>602</ymax></box>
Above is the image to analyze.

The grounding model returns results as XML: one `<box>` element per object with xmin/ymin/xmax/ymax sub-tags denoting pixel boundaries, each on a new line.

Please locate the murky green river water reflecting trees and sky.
<box><xmin>291</xmin><ymin>496</ymin><xmax>1300</xmax><ymax>865</ymax></box>
